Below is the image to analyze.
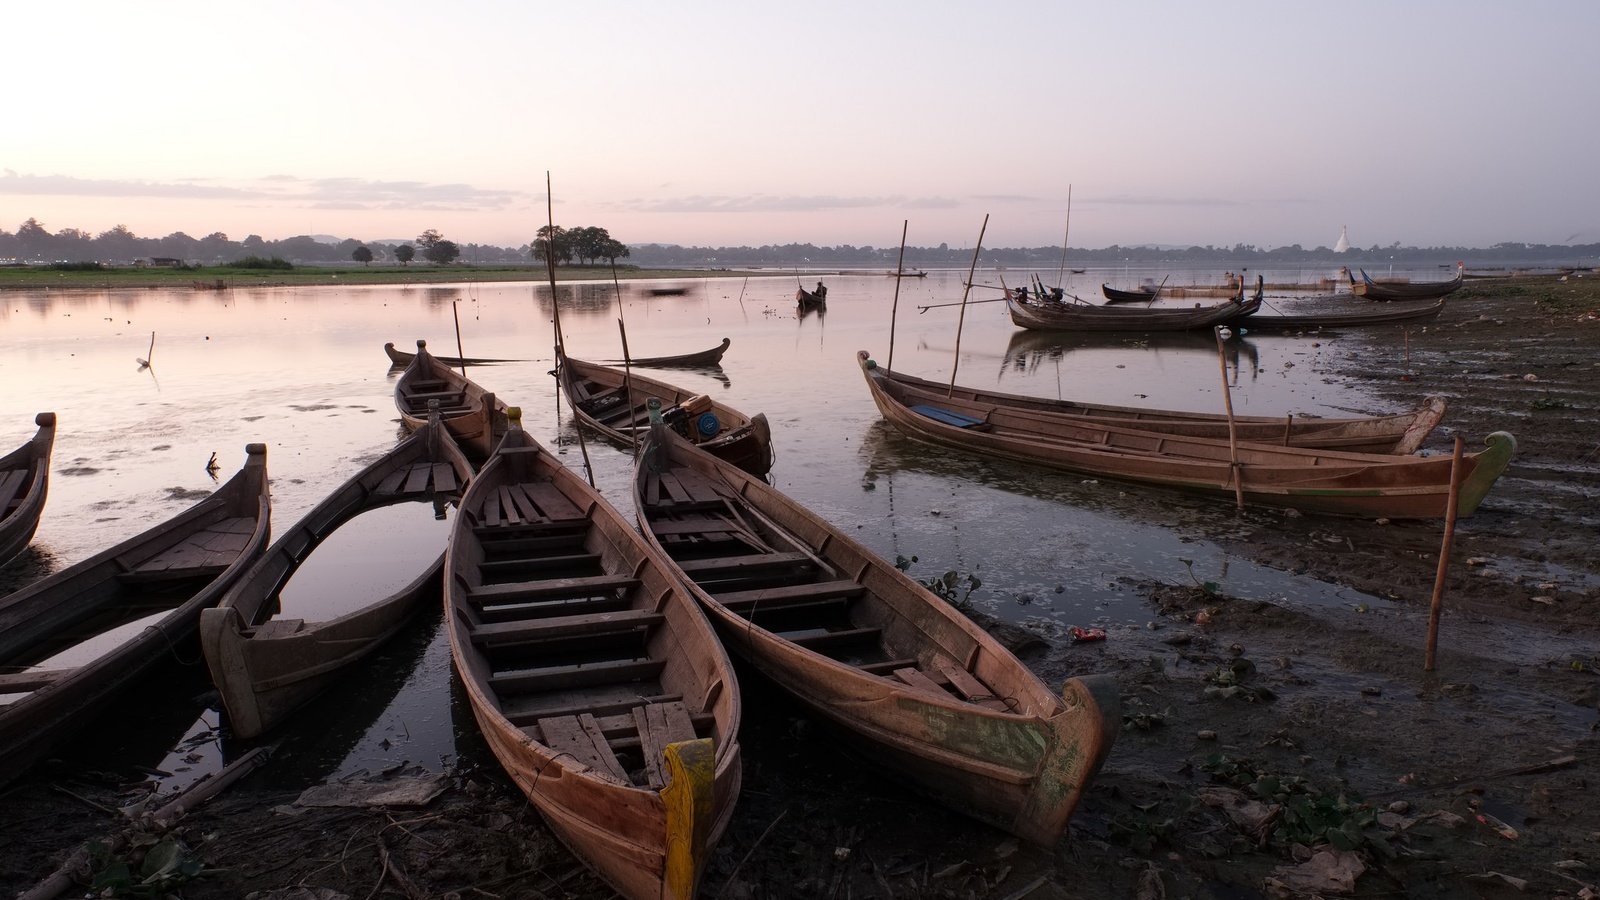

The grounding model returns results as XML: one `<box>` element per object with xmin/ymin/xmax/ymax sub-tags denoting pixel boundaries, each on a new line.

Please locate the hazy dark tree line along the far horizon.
<box><xmin>0</xmin><ymin>218</ymin><xmax>1600</xmax><ymax>271</ymax></box>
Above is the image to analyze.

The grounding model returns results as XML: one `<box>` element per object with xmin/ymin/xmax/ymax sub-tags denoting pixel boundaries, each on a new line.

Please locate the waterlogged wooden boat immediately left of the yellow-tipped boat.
<box><xmin>200</xmin><ymin>406</ymin><xmax>472</xmax><ymax>738</ymax></box>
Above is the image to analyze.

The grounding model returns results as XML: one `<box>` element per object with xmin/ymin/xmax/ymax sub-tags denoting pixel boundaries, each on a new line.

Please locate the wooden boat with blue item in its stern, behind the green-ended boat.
<box><xmin>557</xmin><ymin>357</ymin><xmax>773</xmax><ymax>476</ymax></box>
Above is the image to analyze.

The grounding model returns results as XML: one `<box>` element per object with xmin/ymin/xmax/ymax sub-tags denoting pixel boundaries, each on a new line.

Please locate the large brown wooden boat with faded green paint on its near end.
<box><xmin>634</xmin><ymin>413</ymin><xmax>1122</xmax><ymax>846</ymax></box>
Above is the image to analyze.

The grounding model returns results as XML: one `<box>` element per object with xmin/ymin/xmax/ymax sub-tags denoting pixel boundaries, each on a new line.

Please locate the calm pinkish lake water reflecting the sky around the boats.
<box><xmin>0</xmin><ymin>269</ymin><xmax>1434</xmax><ymax>781</ymax></box>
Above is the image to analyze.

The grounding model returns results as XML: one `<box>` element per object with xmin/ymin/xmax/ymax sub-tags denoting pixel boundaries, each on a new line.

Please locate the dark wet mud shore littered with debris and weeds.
<box><xmin>0</xmin><ymin>277</ymin><xmax>1600</xmax><ymax>898</ymax></box>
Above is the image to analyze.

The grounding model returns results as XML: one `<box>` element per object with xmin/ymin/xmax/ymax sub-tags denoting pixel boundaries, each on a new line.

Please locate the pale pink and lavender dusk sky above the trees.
<box><xmin>0</xmin><ymin>0</ymin><xmax>1600</xmax><ymax>248</ymax></box>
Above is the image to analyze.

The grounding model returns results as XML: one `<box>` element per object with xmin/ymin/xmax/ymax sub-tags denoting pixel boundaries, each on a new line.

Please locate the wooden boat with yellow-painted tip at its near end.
<box><xmin>445</xmin><ymin>409</ymin><xmax>741</xmax><ymax>900</ymax></box>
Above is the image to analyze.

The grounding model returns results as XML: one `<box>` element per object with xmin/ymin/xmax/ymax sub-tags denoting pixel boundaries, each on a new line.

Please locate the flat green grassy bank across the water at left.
<box><xmin>0</xmin><ymin>264</ymin><xmax>747</xmax><ymax>290</ymax></box>
